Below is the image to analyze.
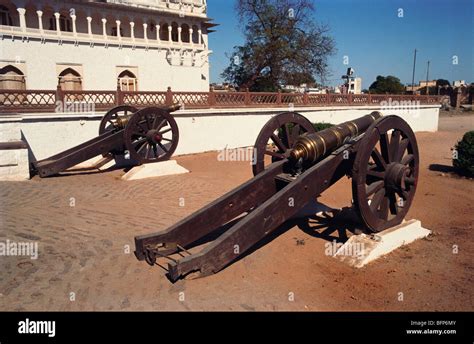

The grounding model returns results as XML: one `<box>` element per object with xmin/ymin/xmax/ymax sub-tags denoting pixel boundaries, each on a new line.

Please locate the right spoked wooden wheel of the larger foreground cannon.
<box><xmin>352</xmin><ymin>116</ymin><xmax>419</xmax><ymax>232</ymax></box>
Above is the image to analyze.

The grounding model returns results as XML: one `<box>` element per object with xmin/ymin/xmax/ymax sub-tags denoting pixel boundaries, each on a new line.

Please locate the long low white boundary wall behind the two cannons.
<box><xmin>0</xmin><ymin>105</ymin><xmax>439</xmax><ymax>161</ymax></box>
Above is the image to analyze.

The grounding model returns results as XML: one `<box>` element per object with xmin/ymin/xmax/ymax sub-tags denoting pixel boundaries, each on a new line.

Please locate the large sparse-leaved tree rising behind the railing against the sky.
<box><xmin>222</xmin><ymin>0</ymin><xmax>335</xmax><ymax>91</ymax></box>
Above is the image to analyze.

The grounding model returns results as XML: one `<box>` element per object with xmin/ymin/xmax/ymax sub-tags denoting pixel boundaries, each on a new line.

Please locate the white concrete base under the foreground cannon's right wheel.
<box><xmin>334</xmin><ymin>220</ymin><xmax>431</xmax><ymax>268</ymax></box>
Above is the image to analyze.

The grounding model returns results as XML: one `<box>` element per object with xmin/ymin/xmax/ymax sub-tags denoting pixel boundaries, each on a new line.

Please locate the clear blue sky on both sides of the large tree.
<box><xmin>208</xmin><ymin>0</ymin><xmax>474</xmax><ymax>88</ymax></box>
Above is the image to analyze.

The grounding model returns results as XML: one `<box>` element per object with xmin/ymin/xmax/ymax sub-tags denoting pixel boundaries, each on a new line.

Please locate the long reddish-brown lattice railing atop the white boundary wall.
<box><xmin>0</xmin><ymin>88</ymin><xmax>442</xmax><ymax>114</ymax></box>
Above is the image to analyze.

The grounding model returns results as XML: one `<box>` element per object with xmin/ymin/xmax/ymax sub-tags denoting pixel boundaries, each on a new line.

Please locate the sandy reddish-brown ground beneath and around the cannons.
<box><xmin>0</xmin><ymin>115</ymin><xmax>474</xmax><ymax>311</ymax></box>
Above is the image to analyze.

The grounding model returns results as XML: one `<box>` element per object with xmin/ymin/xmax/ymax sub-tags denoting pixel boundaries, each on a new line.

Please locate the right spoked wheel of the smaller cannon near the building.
<box><xmin>124</xmin><ymin>107</ymin><xmax>179</xmax><ymax>164</ymax></box>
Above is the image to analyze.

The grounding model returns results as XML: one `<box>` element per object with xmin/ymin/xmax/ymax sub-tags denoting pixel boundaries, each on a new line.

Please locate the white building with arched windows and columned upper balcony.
<box><xmin>0</xmin><ymin>0</ymin><xmax>215</xmax><ymax>91</ymax></box>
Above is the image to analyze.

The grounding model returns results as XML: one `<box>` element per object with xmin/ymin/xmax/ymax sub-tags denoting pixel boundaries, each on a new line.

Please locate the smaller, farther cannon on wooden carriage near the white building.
<box><xmin>31</xmin><ymin>105</ymin><xmax>180</xmax><ymax>177</ymax></box>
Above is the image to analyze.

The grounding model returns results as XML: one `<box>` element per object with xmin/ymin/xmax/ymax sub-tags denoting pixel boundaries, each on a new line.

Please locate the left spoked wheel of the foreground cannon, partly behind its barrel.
<box><xmin>252</xmin><ymin>112</ymin><xmax>315</xmax><ymax>176</ymax></box>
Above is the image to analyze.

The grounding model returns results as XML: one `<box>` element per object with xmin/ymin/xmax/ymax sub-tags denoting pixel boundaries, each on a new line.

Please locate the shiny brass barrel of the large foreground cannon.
<box><xmin>290</xmin><ymin>111</ymin><xmax>382</xmax><ymax>163</ymax></box>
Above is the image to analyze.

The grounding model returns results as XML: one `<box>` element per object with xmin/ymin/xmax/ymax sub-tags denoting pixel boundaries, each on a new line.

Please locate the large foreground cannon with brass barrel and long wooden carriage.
<box><xmin>135</xmin><ymin>112</ymin><xmax>419</xmax><ymax>281</ymax></box>
